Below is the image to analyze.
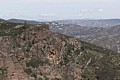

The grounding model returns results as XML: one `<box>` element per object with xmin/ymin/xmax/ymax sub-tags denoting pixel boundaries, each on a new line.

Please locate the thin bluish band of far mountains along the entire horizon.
<box><xmin>0</xmin><ymin>18</ymin><xmax>120</xmax><ymax>27</ymax></box>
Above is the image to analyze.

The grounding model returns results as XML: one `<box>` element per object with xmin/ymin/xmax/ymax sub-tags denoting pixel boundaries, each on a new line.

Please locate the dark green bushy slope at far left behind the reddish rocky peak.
<box><xmin>0</xmin><ymin>21</ymin><xmax>28</xmax><ymax>36</ymax></box>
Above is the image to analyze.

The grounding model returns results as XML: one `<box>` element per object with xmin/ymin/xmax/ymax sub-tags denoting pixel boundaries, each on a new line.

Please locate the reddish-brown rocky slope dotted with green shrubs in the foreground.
<box><xmin>0</xmin><ymin>24</ymin><xmax>120</xmax><ymax>80</ymax></box>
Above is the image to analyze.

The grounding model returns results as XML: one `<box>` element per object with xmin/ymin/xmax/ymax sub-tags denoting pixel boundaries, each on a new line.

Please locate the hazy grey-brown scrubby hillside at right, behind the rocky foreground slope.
<box><xmin>50</xmin><ymin>22</ymin><xmax>120</xmax><ymax>53</ymax></box>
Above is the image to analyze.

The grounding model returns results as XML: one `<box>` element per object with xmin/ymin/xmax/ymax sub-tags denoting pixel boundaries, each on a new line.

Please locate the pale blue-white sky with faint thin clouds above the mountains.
<box><xmin>0</xmin><ymin>0</ymin><xmax>120</xmax><ymax>21</ymax></box>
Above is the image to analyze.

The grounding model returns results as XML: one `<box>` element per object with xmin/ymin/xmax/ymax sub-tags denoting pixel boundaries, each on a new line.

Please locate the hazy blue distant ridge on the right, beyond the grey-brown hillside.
<box><xmin>55</xmin><ymin>19</ymin><xmax>120</xmax><ymax>27</ymax></box>
